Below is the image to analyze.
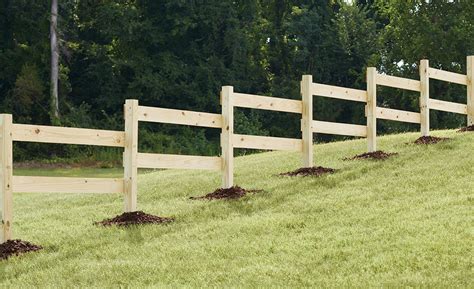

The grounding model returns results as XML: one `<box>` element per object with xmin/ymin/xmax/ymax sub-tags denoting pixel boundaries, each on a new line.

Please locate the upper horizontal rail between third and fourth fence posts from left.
<box><xmin>232</xmin><ymin>93</ymin><xmax>303</xmax><ymax>114</ymax></box>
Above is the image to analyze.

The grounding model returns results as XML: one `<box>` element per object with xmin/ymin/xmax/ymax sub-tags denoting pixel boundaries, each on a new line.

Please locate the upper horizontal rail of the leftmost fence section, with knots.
<box><xmin>12</xmin><ymin>124</ymin><xmax>125</xmax><ymax>147</ymax></box>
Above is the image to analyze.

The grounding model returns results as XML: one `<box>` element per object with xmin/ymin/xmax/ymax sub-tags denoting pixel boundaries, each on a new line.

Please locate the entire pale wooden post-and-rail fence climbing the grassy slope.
<box><xmin>0</xmin><ymin>56</ymin><xmax>474</xmax><ymax>242</ymax></box>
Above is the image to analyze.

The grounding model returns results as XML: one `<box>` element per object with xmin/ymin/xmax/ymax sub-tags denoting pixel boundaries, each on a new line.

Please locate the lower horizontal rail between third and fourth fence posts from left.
<box><xmin>233</xmin><ymin>134</ymin><xmax>303</xmax><ymax>151</ymax></box>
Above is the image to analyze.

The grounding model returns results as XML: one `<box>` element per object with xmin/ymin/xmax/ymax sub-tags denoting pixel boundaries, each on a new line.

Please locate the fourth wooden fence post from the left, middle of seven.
<box><xmin>300</xmin><ymin>75</ymin><xmax>313</xmax><ymax>167</ymax></box>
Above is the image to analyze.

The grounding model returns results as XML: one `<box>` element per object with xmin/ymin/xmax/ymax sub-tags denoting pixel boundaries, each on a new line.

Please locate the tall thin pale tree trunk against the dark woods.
<box><xmin>50</xmin><ymin>0</ymin><xmax>59</xmax><ymax>123</ymax></box>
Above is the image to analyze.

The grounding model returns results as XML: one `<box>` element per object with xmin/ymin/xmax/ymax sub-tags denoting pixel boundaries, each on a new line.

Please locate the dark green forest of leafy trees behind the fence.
<box><xmin>0</xmin><ymin>0</ymin><xmax>474</xmax><ymax>161</ymax></box>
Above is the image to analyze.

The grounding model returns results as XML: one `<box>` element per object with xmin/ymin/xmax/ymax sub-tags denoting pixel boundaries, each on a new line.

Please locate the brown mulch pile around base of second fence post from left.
<box><xmin>94</xmin><ymin>211</ymin><xmax>174</xmax><ymax>227</ymax></box>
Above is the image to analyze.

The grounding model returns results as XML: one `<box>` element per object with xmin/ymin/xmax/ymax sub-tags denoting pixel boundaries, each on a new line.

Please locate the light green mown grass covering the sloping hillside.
<box><xmin>0</xmin><ymin>131</ymin><xmax>474</xmax><ymax>288</ymax></box>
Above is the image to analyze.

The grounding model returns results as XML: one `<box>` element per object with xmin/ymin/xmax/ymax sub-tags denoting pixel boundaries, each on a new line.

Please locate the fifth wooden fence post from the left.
<box><xmin>366</xmin><ymin>67</ymin><xmax>377</xmax><ymax>152</ymax></box>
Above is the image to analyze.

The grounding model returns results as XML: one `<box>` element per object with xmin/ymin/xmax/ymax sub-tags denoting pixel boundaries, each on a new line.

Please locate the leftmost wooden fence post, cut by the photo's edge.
<box><xmin>0</xmin><ymin>114</ymin><xmax>13</xmax><ymax>243</ymax></box>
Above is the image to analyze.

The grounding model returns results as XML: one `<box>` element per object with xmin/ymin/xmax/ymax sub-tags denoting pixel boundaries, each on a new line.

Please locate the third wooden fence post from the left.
<box><xmin>221</xmin><ymin>86</ymin><xmax>234</xmax><ymax>188</ymax></box>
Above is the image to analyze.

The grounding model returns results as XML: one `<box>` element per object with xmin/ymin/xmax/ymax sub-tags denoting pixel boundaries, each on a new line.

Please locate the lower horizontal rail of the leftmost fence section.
<box><xmin>13</xmin><ymin>176</ymin><xmax>124</xmax><ymax>194</ymax></box>
